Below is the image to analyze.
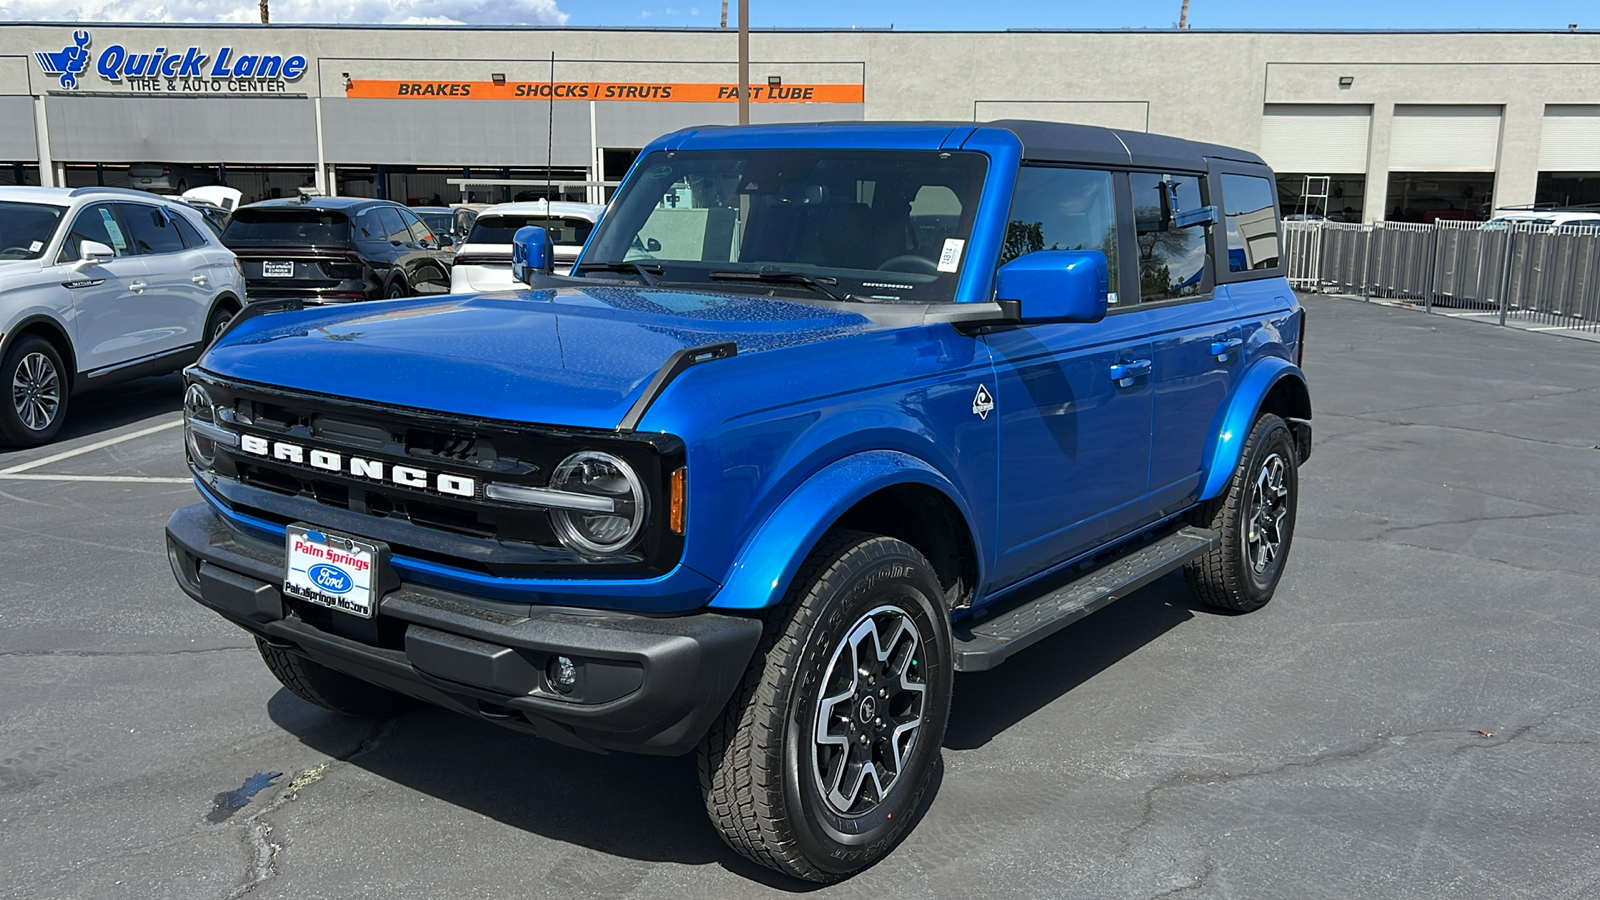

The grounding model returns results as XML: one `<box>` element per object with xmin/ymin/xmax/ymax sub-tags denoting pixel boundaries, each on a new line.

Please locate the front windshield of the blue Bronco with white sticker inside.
<box><xmin>581</xmin><ymin>149</ymin><xmax>987</xmax><ymax>303</ymax></box>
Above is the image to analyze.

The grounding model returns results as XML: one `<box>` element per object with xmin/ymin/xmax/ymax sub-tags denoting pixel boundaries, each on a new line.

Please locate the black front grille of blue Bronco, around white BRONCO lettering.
<box><xmin>192</xmin><ymin>378</ymin><xmax>683</xmax><ymax>577</ymax></box>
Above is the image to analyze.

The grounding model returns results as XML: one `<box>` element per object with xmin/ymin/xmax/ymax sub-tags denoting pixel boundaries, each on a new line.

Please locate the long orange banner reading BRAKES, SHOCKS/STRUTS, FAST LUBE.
<box><xmin>344</xmin><ymin>78</ymin><xmax>862</xmax><ymax>102</ymax></box>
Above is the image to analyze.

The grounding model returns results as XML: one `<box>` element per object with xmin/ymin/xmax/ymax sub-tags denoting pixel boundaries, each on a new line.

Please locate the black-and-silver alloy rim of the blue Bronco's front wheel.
<box><xmin>811</xmin><ymin>605</ymin><xmax>928</xmax><ymax>817</ymax></box>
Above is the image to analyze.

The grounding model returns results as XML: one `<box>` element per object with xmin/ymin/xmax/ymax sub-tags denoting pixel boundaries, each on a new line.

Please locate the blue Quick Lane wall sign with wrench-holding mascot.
<box><xmin>34</xmin><ymin>30</ymin><xmax>307</xmax><ymax>93</ymax></box>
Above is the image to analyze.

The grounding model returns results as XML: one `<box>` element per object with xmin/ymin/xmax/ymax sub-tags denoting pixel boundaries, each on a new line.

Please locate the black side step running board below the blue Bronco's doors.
<box><xmin>955</xmin><ymin>527</ymin><xmax>1222</xmax><ymax>673</ymax></box>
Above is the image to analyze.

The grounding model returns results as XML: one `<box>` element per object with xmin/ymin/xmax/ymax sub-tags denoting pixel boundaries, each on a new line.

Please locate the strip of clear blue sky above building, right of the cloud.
<box><xmin>560</xmin><ymin>0</ymin><xmax>1600</xmax><ymax>30</ymax></box>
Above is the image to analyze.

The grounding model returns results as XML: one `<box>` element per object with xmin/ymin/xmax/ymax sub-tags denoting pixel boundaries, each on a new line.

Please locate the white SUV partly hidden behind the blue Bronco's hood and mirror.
<box><xmin>450</xmin><ymin>200</ymin><xmax>605</xmax><ymax>293</ymax></box>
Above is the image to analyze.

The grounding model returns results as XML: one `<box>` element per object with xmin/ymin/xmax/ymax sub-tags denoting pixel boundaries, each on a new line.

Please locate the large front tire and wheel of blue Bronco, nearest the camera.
<box><xmin>699</xmin><ymin>532</ymin><xmax>954</xmax><ymax>882</ymax></box>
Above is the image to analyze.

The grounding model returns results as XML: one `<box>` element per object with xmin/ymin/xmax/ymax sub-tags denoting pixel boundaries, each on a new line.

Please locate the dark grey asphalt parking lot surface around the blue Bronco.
<box><xmin>0</xmin><ymin>298</ymin><xmax>1600</xmax><ymax>900</ymax></box>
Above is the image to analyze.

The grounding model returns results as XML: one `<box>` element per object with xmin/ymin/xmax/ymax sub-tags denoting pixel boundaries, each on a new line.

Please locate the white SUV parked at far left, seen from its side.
<box><xmin>0</xmin><ymin>187</ymin><xmax>246</xmax><ymax>447</ymax></box>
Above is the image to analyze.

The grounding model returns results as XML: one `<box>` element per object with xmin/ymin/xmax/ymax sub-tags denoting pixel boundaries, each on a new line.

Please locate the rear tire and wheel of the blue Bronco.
<box><xmin>1184</xmin><ymin>413</ymin><xmax>1299</xmax><ymax>612</ymax></box>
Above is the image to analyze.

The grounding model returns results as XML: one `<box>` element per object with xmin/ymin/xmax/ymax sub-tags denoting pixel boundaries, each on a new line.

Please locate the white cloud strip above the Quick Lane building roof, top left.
<box><xmin>0</xmin><ymin>0</ymin><xmax>566</xmax><ymax>26</ymax></box>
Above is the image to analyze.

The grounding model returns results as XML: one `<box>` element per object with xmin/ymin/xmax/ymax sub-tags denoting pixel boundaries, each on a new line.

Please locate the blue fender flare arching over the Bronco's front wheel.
<box><xmin>710</xmin><ymin>450</ymin><xmax>984</xmax><ymax>610</ymax></box>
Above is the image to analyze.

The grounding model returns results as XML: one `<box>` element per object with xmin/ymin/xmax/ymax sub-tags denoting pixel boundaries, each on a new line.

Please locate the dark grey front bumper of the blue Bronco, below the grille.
<box><xmin>166</xmin><ymin>503</ymin><xmax>762</xmax><ymax>756</ymax></box>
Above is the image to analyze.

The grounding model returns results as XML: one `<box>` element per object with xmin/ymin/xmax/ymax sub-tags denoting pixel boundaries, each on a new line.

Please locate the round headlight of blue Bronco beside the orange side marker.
<box><xmin>550</xmin><ymin>450</ymin><xmax>646</xmax><ymax>556</ymax></box>
